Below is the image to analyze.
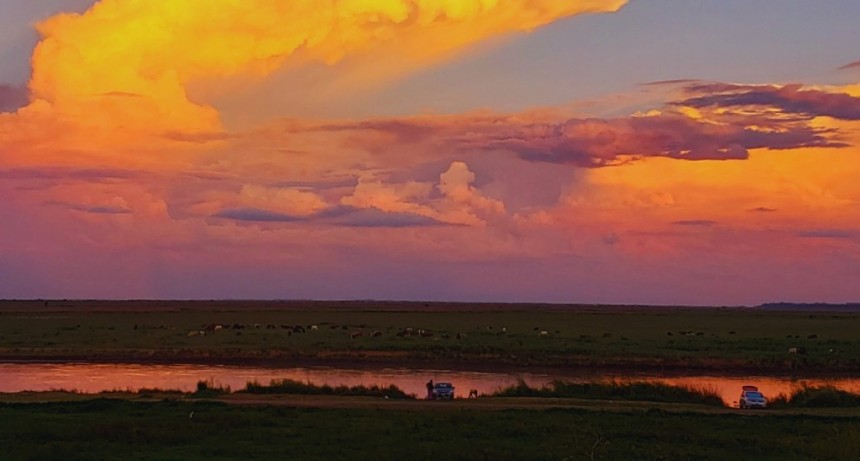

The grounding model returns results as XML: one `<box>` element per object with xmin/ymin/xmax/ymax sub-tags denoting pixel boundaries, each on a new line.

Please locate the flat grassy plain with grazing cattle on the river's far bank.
<box><xmin>0</xmin><ymin>301</ymin><xmax>860</xmax><ymax>373</ymax></box>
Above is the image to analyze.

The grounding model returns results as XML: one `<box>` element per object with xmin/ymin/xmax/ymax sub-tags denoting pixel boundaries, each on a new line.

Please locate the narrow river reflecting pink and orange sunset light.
<box><xmin>0</xmin><ymin>363</ymin><xmax>860</xmax><ymax>405</ymax></box>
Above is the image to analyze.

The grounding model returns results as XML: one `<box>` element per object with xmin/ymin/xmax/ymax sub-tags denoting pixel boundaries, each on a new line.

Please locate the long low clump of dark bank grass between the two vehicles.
<box><xmin>493</xmin><ymin>380</ymin><xmax>725</xmax><ymax>407</ymax></box>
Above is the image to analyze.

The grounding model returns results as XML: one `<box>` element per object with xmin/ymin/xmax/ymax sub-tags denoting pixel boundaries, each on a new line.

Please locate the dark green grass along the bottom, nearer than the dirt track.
<box><xmin>0</xmin><ymin>399</ymin><xmax>860</xmax><ymax>461</ymax></box>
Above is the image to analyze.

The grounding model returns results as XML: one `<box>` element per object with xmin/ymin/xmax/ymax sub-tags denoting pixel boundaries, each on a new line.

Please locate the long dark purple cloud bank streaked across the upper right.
<box><xmin>299</xmin><ymin>80</ymin><xmax>860</xmax><ymax>168</ymax></box>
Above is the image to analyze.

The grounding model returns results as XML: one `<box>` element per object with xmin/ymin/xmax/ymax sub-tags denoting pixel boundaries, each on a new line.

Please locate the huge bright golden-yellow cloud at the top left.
<box><xmin>25</xmin><ymin>0</ymin><xmax>626</xmax><ymax>132</ymax></box>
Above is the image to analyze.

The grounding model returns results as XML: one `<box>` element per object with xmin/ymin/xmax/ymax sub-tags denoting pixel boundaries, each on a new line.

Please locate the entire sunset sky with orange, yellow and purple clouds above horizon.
<box><xmin>0</xmin><ymin>0</ymin><xmax>860</xmax><ymax>305</ymax></box>
